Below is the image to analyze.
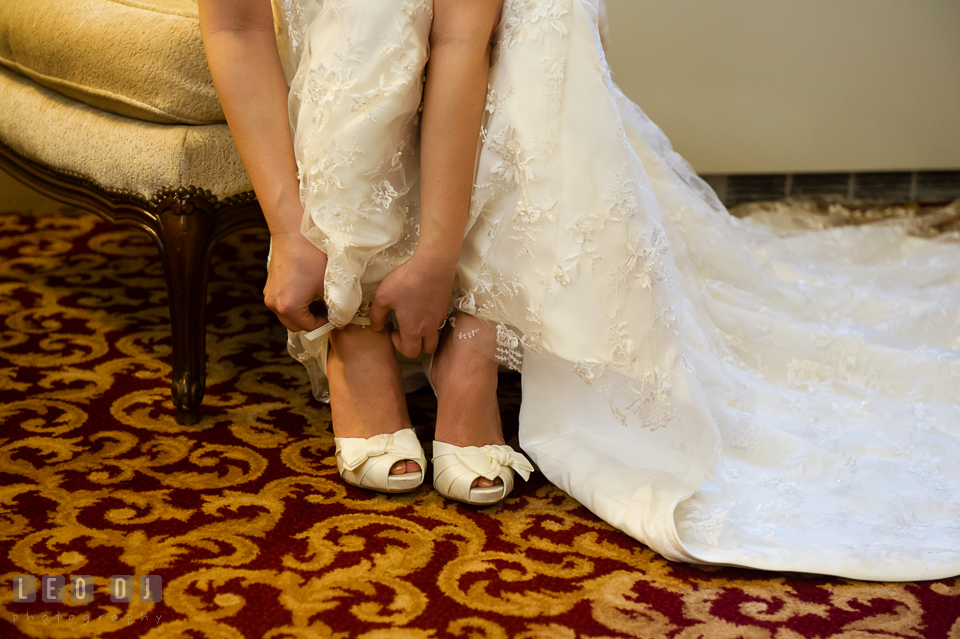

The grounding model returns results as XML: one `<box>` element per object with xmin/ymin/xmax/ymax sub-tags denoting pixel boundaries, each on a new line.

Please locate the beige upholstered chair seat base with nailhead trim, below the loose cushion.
<box><xmin>0</xmin><ymin>66</ymin><xmax>252</xmax><ymax>199</ymax></box>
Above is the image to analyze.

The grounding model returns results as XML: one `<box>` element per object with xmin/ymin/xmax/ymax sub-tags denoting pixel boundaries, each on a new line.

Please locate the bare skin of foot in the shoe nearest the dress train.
<box><xmin>432</xmin><ymin>313</ymin><xmax>504</xmax><ymax>488</ymax></box>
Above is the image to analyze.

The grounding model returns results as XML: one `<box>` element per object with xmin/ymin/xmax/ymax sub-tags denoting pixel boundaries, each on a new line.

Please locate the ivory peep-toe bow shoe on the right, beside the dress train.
<box><xmin>433</xmin><ymin>441</ymin><xmax>533</xmax><ymax>506</ymax></box>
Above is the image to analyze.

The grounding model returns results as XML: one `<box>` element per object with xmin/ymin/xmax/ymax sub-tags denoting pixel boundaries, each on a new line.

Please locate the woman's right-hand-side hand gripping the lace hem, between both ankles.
<box><xmin>370</xmin><ymin>253</ymin><xmax>456</xmax><ymax>357</ymax></box>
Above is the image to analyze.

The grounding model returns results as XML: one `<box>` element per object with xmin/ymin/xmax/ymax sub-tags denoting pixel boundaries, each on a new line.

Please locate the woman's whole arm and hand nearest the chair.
<box><xmin>198</xmin><ymin>0</ymin><xmax>327</xmax><ymax>331</ymax></box>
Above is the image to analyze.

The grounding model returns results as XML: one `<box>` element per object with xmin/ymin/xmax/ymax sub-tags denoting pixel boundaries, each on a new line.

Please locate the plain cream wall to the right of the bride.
<box><xmin>607</xmin><ymin>0</ymin><xmax>960</xmax><ymax>173</ymax></box>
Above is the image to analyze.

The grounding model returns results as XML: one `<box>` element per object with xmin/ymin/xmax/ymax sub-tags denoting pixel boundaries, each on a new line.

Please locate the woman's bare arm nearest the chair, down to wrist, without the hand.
<box><xmin>199</xmin><ymin>0</ymin><xmax>303</xmax><ymax>235</ymax></box>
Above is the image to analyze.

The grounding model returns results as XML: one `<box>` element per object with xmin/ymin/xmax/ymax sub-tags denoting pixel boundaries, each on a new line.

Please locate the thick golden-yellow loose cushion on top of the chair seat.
<box><xmin>0</xmin><ymin>0</ymin><xmax>224</xmax><ymax>124</ymax></box>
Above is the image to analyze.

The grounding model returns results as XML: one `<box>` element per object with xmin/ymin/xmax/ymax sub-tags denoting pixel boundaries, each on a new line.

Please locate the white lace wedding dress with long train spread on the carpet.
<box><xmin>275</xmin><ymin>0</ymin><xmax>960</xmax><ymax>580</ymax></box>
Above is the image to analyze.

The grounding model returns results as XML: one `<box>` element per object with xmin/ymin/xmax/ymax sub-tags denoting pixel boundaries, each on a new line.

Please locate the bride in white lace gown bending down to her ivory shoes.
<box><xmin>200</xmin><ymin>0</ymin><xmax>960</xmax><ymax>580</ymax></box>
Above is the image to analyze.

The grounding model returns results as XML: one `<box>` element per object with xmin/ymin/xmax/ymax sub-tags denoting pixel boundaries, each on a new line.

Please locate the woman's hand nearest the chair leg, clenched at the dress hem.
<box><xmin>263</xmin><ymin>231</ymin><xmax>327</xmax><ymax>331</ymax></box>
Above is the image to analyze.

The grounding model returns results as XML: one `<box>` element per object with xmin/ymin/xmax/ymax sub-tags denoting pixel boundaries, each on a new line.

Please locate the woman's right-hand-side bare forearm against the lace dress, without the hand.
<box><xmin>417</xmin><ymin>0</ymin><xmax>502</xmax><ymax>269</ymax></box>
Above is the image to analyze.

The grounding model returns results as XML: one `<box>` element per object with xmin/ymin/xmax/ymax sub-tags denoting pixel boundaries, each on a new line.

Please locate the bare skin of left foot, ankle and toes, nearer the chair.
<box><xmin>327</xmin><ymin>324</ymin><xmax>421</xmax><ymax>475</ymax></box>
